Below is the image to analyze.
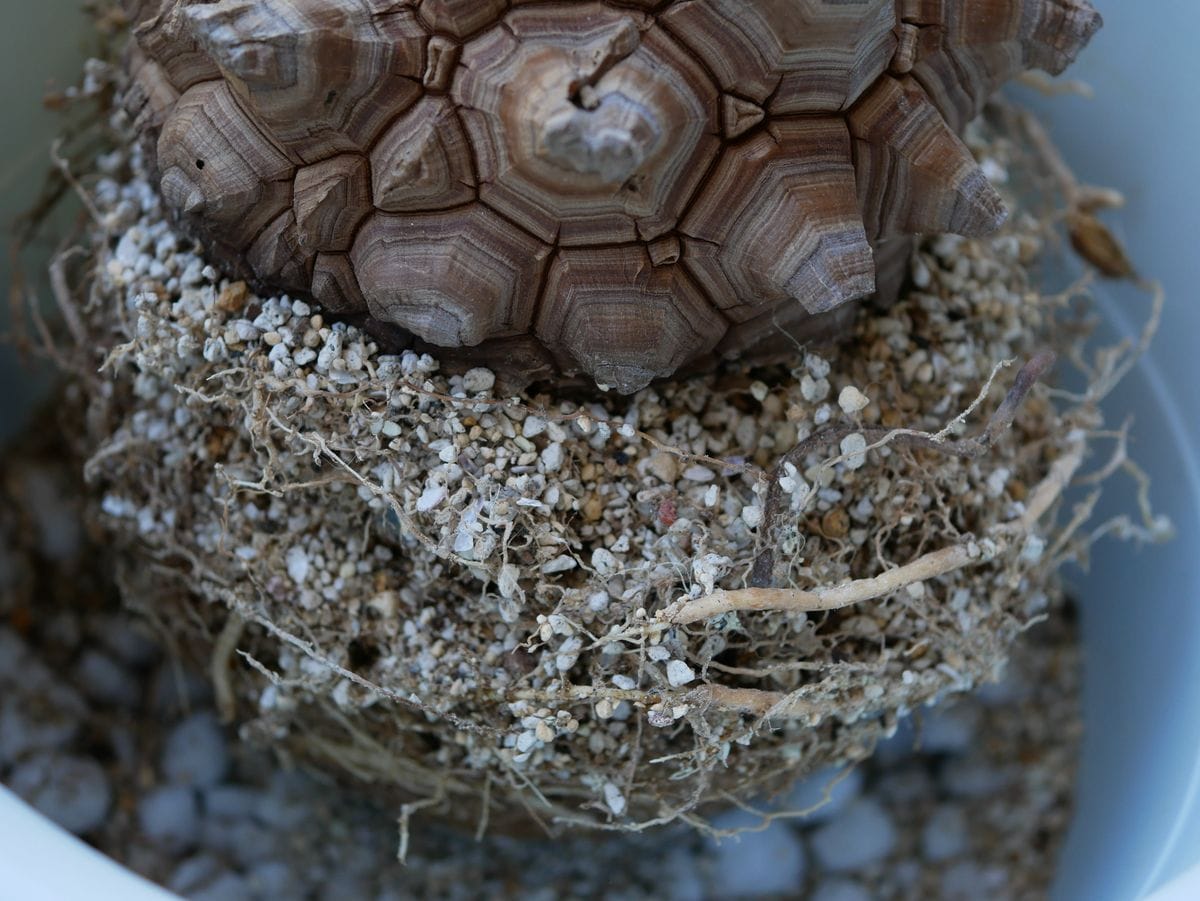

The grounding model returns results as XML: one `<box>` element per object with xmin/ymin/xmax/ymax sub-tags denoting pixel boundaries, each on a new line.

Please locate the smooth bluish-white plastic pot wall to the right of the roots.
<box><xmin>1014</xmin><ymin>0</ymin><xmax>1200</xmax><ymax>901</ymax></box>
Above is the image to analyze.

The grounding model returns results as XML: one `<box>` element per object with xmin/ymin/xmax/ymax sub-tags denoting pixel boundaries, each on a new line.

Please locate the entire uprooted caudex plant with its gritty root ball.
<box><xmin>46</xmin><ymin>0</ymin><xmax>1161</xmax><ymax>829</ymax></box>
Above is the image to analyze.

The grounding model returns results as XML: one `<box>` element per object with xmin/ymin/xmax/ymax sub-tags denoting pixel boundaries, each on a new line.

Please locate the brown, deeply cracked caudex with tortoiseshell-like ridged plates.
<box><xmin>125</xmin><ymin>0</ymin><xmax>1100</xmax><ymax>392</ymax></box>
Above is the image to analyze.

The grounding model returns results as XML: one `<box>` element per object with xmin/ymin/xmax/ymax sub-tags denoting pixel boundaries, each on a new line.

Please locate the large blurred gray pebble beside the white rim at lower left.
<box><xmin>8</xmin><ymin>752</ymin><xmax>113</xmax><ymax>835</ymax></box>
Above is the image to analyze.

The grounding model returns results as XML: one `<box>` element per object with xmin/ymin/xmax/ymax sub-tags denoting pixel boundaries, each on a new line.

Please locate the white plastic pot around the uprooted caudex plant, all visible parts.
<box><xmin>0</xmin><ymin>0</ymin><xmax>1200</xmax><ymax>901</ymax></box>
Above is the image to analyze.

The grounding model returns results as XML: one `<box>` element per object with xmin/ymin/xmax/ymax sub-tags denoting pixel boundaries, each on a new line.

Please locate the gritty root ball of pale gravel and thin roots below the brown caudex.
<box><xmin>44</xmin><ymin>84</ymin><xmax>1162</xmax><ymax>830</ymax></box>
